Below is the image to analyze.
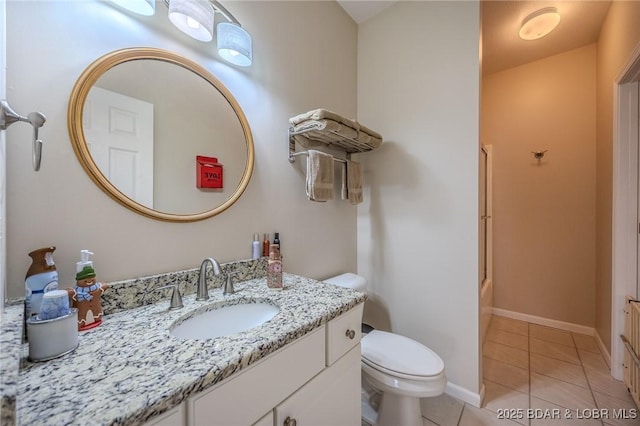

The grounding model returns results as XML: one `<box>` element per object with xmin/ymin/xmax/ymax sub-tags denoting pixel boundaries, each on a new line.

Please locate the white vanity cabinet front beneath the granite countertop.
<box><xmin>186</xmin><ymin>303</ymin><xmax>363</xmax><ymax>426</ymax></box>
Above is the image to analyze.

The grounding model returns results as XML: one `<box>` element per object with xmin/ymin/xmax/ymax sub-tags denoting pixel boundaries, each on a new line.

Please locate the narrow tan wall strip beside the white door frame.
<box><xmin>595</xmin><ymin>1</ymin><xmax>640</xmax><ymax>351</ymax></box>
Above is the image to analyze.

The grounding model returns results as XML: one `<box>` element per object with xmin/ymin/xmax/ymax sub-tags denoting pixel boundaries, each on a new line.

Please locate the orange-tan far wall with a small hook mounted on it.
<box><xmin>481</xmin><ymin>44</ymin><xmax>596</xmax><ymax>327</ymax></box>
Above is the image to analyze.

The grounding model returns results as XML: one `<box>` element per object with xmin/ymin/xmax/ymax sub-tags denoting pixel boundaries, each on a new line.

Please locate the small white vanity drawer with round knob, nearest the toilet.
<box><xmin>327</xmin><ymin>303</ymin><xmax>364</xmax><ymax>366</ymax></box>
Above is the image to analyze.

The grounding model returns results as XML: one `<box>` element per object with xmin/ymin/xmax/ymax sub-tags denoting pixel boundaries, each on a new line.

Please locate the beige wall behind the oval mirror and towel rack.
<box><xmin>6</xmin><ymin>1</ymin><xmax>357</xmax><ymax>297</ymax></box>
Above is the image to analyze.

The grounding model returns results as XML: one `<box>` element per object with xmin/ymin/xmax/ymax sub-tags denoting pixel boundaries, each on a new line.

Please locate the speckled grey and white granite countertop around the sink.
<box><xmin>10</xmin><ymin>274</ymin><xmax>366</xmax><ymax>426</ymax></box>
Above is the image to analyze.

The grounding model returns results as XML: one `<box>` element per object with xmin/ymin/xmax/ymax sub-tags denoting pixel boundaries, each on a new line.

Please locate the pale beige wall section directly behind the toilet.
<box><xmin>358</xmin><ymin>1</ymin><xmax>480</xmax><ymax>402</ymax></box>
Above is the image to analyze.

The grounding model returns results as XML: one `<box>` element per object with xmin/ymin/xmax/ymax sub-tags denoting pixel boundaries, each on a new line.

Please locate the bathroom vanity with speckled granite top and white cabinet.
<box><xmin>7</xmin><ymin>274</ymin><xmax>366</xmax><ymax>426</ymax></box>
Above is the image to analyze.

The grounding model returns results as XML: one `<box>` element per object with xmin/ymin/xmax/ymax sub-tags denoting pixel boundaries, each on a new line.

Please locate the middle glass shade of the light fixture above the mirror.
<box><xmin>169</xmin><ymin>0</ymin><xmax>213</xmax><ymax>41</ymax></box>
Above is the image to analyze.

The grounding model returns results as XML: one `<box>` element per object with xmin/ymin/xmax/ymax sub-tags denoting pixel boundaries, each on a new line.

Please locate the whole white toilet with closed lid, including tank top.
<box><xmin>324</xmin><ymin>273</ymin><xmax>447</xmax><ymax>426</ymax></box>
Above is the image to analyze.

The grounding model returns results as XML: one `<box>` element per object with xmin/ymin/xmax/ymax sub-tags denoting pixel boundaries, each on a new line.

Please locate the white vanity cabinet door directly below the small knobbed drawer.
<box><xmin>275</xmin><ymin>344</ymin><xmax>361</xmax><ymax>426</ymax></box>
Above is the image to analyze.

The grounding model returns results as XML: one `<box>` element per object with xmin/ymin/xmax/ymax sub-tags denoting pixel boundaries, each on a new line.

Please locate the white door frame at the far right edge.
<box><xmin>611</xmin><ymin>40</ymin><xmax>640</xmax><ymax>380</ymax></box>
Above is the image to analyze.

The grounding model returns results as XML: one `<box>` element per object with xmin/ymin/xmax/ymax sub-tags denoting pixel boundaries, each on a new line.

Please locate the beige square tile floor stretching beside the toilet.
<box><xmin>422</xmin><ymin>316</ymin><xmax>640</xmax><ymax>426</ymax></box>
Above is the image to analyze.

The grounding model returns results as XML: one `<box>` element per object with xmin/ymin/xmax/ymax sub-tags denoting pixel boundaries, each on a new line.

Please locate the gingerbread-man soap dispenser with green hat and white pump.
<box><xmin>67</xmin><ymin>250</ymin><xmax>109</xmax><ymax>331</ymax></box>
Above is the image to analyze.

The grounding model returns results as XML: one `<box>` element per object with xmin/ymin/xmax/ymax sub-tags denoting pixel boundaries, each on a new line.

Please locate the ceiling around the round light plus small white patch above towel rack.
<box><xmin>338</xmin><ymin>0</ymin><xmax>611</xmax><ymax>74</ymax></box>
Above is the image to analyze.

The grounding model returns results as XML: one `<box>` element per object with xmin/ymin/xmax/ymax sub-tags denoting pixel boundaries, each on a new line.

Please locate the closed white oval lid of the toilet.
<box><xmin>361</xmin><ymin>330</ymin><xmax>444</xmax><ymax>377</ymax></box>
